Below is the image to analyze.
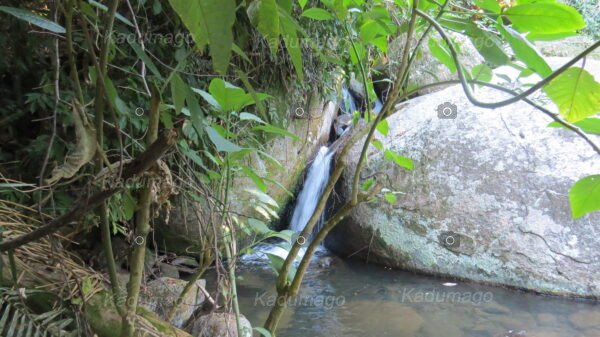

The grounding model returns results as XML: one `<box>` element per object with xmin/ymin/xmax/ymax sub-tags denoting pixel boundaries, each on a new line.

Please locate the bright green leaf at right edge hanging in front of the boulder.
<box><xmin>569</xmin><ymin>175</ymin><xmax>600</xmax><ymax>219</ymax></box>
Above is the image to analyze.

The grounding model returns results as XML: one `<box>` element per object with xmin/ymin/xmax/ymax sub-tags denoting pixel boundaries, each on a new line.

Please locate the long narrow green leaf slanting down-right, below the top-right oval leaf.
<box><xmin>497</xmin><ymin>24</ymin><xmax>552</xmax><ymax>77</ymax></box>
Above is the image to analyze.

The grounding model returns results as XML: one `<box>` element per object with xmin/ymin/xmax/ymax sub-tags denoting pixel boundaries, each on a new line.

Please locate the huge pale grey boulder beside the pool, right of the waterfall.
<box><xmin>326</xmin><ymin>86</ymin><xmax>600</xmax><ymax>298</ymax></box>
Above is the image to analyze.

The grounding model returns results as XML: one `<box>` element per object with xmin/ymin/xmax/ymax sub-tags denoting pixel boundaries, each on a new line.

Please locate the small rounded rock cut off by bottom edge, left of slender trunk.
<box><xmin>191</xmin><ymin>313</ymin><xmax>252</xmax><ymax>337</ymax></box>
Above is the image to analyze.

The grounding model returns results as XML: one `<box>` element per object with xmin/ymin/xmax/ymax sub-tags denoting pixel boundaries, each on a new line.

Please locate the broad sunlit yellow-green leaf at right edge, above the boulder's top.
<box><xmin>544</xmin><ymin>67</ymin><xmax>600</xmax><ymax>122</ymax></box>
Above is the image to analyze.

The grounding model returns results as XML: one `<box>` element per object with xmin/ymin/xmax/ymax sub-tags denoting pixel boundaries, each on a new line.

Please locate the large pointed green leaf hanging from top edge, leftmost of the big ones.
<box><xmin>169</xmin><ymin>0</ymin><xmax>236</xmax><ymax>74</ymax></box>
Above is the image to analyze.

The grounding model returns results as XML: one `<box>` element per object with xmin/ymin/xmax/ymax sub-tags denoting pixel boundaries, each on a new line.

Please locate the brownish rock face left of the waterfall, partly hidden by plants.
<box><xmin>154</xmin><ymin>95</ymin><xmax>337</xmax><ymax>255</ymax></box>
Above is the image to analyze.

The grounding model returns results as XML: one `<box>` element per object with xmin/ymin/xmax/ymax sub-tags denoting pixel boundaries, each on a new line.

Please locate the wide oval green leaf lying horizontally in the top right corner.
<box><xmin>503</xmin><ymin>2</ymin><xmax>585</xmax><ymax>34</ymax></box>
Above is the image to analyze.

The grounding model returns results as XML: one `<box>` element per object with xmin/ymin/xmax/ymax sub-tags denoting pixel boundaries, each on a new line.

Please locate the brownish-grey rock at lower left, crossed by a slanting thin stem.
<box><xmin>140</xmin><ymin>277</ymin><xmax>206</xmax><ymax>328</ymax></box>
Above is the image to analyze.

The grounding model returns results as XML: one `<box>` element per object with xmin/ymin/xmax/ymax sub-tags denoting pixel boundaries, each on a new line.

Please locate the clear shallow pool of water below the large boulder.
<box><xmin>238</xmin><ymin>249</ymin><xmax>600</xmax><ymax>337</ymax></box>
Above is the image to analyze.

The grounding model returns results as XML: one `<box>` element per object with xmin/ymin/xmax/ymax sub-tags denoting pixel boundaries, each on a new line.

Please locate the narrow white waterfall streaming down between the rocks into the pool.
<box><xmin>290</xmin><ymin>146</ymin><xmax>333</xmax><ymax>232</ymax></box>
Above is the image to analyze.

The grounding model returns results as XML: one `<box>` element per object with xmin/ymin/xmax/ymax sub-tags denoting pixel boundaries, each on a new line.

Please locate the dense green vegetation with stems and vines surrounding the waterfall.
<box><xmin>0</xmin><ymin>0</ymin><xmax>600</xmax><ymax>336</ymax></box>
